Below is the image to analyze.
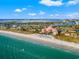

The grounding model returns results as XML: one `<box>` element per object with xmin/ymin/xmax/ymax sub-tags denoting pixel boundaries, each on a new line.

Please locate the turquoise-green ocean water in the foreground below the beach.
<box><xmin>0</xmin><ymin>35</ymin><xmax>79</xmax><ymax>59</ymax></box>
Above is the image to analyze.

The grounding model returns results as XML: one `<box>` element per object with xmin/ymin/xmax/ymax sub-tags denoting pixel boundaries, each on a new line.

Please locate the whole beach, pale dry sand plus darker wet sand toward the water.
<box><xmin>0</xmin><ymin>30</ymin><xmax>79</xmax><ymax>53</ymax></box>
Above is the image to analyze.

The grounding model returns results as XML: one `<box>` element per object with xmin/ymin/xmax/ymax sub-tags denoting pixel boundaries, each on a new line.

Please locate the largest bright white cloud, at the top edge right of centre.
<box><xmin>39</xmin><ymin>0</ymin><xmax>63</xmax><ymax>6</ymax></box>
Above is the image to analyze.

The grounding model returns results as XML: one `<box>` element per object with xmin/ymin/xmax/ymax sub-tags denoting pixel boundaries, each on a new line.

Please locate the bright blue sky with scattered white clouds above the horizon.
<box><xmin>0</xmin><ymin>0</ymin><xmax>79</xmax><ymax>19</ymax></box>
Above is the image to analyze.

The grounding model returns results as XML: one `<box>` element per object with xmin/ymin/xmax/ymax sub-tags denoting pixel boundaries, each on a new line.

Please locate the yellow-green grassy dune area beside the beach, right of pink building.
<box><xmin>56</xmin><ymin>34</ymin><xmax>79</xmax><ymax>43</ymax></box>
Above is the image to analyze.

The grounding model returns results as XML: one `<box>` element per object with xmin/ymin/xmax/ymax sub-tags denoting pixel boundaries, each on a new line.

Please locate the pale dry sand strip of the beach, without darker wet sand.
<box><xmin>0</xmin><ymin>30</ymin><xmax>79</xmax><ymax>49</ymax></box>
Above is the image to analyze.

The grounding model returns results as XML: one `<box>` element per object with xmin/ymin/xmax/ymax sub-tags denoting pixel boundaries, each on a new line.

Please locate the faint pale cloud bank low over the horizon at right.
<box><xmin>50</xmin><ymin>12</ymin><xmax>79</xmax><ymax>19</ymax></box>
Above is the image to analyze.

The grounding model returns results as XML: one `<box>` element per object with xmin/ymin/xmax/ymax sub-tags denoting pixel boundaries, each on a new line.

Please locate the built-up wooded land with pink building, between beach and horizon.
<box><xmin>0</xmin><ymin>20</ymin><xmax>79</xmax><ymax>37</ymax></box>
